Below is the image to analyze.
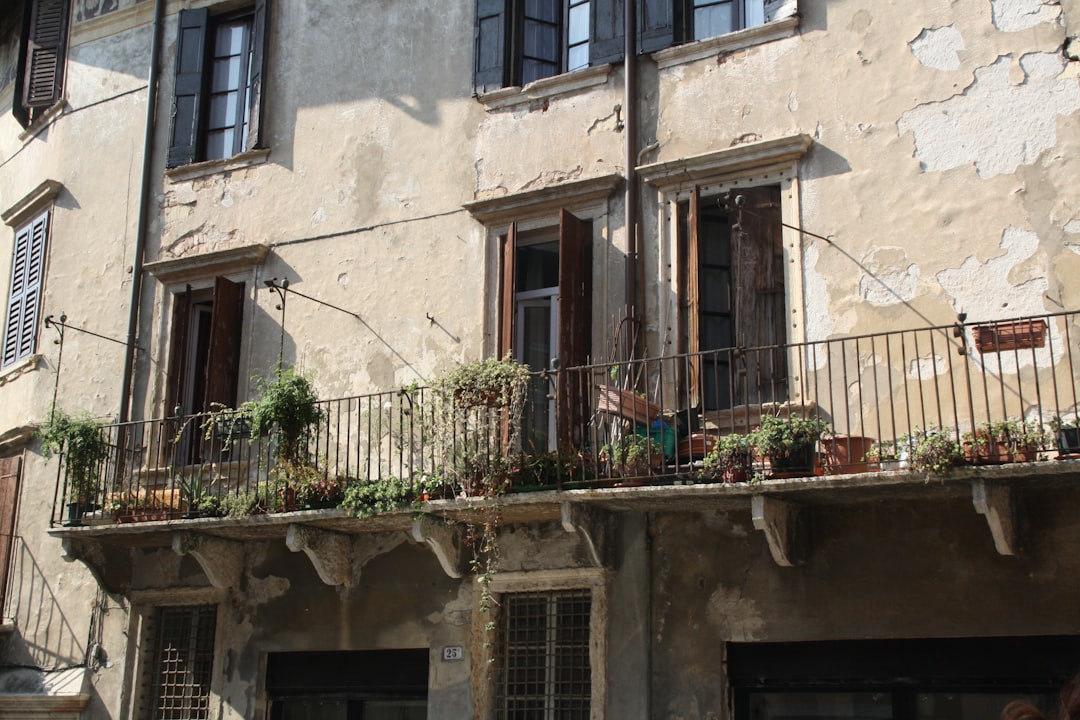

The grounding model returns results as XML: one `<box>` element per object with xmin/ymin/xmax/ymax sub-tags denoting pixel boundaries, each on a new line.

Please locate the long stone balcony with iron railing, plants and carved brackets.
<box><xmin>51</xmin><ymin>313</ymin><xmax>1080</xmax><ymax>576</ymax></box>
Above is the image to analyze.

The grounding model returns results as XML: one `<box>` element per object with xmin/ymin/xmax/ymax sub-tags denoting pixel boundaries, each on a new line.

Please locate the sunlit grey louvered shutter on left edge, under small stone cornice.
<box><xmin>3</xmin><ymin>210</ymin><xmax>50</xmax><ymax>367</ymax></box>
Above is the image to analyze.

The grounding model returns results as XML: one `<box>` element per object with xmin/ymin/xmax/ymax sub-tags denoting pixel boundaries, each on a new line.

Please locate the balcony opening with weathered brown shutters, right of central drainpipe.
<box><xmin>678</xmin><ymin>186</ymin><xmax>787</xmax><ymax>410</ymax></box>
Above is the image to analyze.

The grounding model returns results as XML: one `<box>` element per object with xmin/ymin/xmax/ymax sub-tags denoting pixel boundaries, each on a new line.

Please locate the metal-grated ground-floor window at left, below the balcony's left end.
<box><xmin>150</xmin><ymin>606</ymin><xmax>217</xmax><ymax>720</ymax></box>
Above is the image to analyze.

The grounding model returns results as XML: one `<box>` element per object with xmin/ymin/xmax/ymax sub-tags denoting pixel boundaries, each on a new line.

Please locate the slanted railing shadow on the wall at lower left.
<box><xmin>0</xmin><ymin>538</ymin><xmax>90</xmax><ymax>670</ymax></box>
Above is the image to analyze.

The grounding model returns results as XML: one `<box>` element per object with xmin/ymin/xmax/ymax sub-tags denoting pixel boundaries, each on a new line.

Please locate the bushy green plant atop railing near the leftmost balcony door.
<box><xmin>243</xmin><ymin>368</ymin><xmax>323</xmax><ymax>463</ymax></box>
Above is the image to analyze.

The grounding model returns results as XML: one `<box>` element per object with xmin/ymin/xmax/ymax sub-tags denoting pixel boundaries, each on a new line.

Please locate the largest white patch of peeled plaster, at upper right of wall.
<box><xmin>896</xmin><ymin>53</ymin><xmax>1080</xmax><ymax>178</ymax></box>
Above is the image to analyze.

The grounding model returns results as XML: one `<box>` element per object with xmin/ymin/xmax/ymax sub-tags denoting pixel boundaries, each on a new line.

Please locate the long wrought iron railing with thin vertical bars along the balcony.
<box><xmin>53</xmin><ymin>312</ymin><xmax>1080</xmax><ymax>522</ymax></box>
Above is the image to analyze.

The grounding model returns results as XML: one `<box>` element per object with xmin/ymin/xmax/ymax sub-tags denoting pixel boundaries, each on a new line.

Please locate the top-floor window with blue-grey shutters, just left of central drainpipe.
<box><xmin>474</xmin><ymin>0</ymin><xmax>623</xmax><ymax>94</ymax></box>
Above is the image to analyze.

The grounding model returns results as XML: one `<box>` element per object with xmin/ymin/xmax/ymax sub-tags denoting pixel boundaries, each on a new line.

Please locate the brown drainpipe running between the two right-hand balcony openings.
<box><xmin>622</xmin><ymin>0</ymin><xmax>638</xmax><ymax>356</ymax></box>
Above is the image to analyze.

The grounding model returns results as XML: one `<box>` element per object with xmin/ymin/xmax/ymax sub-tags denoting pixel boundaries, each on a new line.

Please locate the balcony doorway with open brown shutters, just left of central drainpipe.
<box><xmin>499</xmin><ymin>209</ymin><xmax>593</xmax><ymax>452</ymax></box>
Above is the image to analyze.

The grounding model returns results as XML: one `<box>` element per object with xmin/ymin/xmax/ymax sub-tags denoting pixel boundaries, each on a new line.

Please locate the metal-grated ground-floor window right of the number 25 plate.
<box><xmin>496</xmin><ymin>590</ymin><xmax>592</xmax><ymax>720</ymax></box>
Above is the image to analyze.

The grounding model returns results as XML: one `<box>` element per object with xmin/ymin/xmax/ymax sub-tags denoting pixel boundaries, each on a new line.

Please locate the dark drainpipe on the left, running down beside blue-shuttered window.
<box><xmin>119</xmin><ymin>0</ymin><xmax>165</xmax><ymax>422</ymax></box>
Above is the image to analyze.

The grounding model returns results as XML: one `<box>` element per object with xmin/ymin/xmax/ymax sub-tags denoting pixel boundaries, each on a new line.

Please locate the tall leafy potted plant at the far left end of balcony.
<box><xmin>38</xmin><ymin>410</ymin><xmax>109</xmax><ymax>525</ymax></box>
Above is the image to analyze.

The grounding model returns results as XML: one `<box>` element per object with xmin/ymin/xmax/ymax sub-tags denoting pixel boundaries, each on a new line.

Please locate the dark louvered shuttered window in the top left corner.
<box><xmin>14</xmin><ymin>0</ymin><xmax>71</xmax><ymax>127</ymax></box>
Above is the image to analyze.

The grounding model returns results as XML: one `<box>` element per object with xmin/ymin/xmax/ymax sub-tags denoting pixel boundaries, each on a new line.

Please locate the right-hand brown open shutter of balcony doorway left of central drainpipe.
<box><xmin>555</xmin><ymin>210</ymin><xmax>593</xmax><ymax>447</ymax></box>
